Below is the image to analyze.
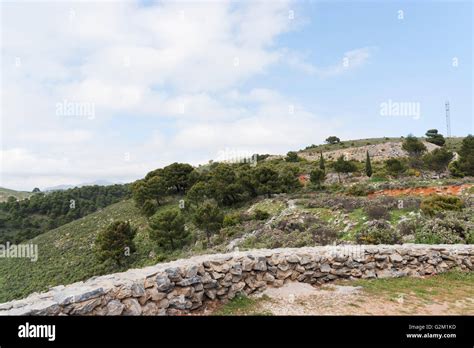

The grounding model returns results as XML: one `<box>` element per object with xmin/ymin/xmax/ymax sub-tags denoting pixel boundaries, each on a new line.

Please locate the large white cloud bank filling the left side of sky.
<box><xmin>0</xmin><ymin>1</ymin><xmax>369</xmax><ymax>189</ymax></box>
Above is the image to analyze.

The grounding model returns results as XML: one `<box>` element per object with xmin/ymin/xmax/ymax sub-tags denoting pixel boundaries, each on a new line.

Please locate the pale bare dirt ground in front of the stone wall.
<box><xmin>255</xmin><ymin>283</ymin><xmax>474</xmax><ymax>315</ymax></box>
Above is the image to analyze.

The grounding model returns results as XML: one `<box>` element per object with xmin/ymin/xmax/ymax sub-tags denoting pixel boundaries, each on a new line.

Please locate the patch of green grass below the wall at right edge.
<box><xmin>352</xmin><ymin>271</ymin><xmax>474</xmax><ymax>302</ymax></box>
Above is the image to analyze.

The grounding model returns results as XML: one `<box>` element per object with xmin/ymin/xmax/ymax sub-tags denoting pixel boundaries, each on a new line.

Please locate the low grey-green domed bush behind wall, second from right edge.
<box><xmin>355</xmin><ymin>220</ymin><xmax>401</xmax><ymax>244</ymax></box>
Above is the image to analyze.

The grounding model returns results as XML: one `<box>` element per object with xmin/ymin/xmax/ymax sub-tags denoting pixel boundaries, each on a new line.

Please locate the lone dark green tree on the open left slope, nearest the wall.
<box><xmin>95</xmin><ymin>221</ymin><xmax>137</xmax><ymax>266</ymax></box>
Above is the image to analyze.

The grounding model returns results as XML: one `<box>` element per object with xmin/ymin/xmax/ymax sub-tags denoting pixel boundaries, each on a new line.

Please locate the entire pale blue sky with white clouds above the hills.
<box><xmin>0</xmin><ymin>0</ymin><xmax>474</xmax><ymax>190</ymax></box>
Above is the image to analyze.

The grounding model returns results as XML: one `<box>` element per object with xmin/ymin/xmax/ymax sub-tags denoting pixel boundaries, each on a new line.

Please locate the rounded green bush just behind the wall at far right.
<box><xmin>415</xmin><ymin>217</ymin><xmax>472</xmax><ymax>244</ymax></box>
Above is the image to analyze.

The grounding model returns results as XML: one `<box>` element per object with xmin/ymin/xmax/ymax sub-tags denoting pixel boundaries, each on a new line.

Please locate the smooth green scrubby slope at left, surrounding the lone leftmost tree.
<box><xmin>0</xmin><ymin>200</ymin><xmax>152</xmax><ymax>302</ymax></box>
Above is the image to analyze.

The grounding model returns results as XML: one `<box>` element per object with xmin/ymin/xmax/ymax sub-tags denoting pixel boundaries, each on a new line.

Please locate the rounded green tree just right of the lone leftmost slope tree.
<box><xmin>149</xmin><ymin>209</ymin><xmax>189</xmax><ymax>250</ymax></box>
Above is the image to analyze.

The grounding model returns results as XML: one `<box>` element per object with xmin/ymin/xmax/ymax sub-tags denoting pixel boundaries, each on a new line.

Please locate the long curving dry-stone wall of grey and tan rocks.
<box><xmin>0</xmin><ymin>244</ymin><xmax>474</xmax><ymax>315</ymax></box>
